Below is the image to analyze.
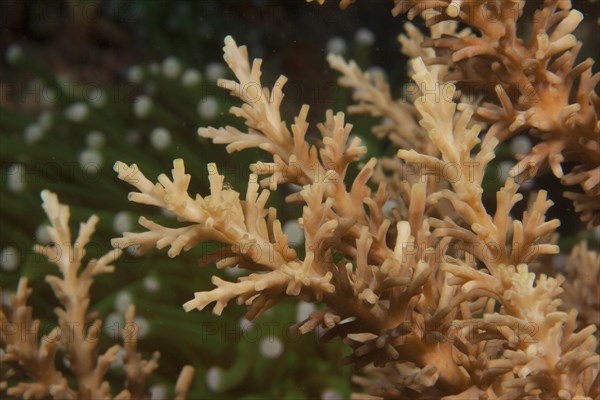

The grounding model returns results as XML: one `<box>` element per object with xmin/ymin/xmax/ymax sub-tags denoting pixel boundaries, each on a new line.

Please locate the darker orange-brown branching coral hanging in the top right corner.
<box><xmin>393</xmin><ymin>0</ymin><xmax>600</xmax><ymax>225</ymax></box>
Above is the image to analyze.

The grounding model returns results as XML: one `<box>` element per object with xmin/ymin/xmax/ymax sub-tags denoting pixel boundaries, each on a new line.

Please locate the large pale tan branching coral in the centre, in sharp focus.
<box><xmin>113</xmin><ymin>25</ymin><xmax>599</xmax><ymax>399</ymax></box>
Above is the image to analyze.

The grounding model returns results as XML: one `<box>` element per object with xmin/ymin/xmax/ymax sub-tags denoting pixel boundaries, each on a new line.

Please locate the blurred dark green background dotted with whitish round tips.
<box><xmin>0</xmin><ymin>0</ymin><xmax>599</xmax><ymax>400</ymax></box>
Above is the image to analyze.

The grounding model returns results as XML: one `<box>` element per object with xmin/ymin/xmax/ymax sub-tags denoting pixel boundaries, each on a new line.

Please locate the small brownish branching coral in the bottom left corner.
<box><xmin>0</xmin><ymin>191</ymin><xmax>193</xmax><ymax>399</ymax></box>
